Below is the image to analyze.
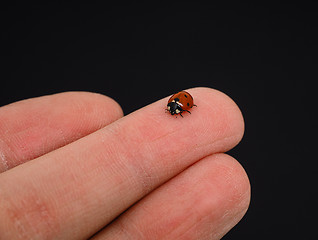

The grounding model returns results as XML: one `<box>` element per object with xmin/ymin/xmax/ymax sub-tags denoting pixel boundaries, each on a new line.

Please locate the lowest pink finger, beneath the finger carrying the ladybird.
<box><xmin>93</xmin><ymin>154</ymin><xmax>250</xmax><ymax>240</ymax></box>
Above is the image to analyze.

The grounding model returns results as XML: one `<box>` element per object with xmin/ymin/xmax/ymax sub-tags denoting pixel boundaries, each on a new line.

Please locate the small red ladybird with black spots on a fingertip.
<box><xmin>166</xmin><ymin>91</ymin><xmax>196</xmax><ymax>117</ymax></box>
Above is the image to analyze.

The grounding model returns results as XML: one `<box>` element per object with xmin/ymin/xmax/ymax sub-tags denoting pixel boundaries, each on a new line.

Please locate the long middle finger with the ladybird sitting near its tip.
<box><xmin>0</xmin><ymin>88</ymin><xmax>244</xmax><ymax>239</ymax></box>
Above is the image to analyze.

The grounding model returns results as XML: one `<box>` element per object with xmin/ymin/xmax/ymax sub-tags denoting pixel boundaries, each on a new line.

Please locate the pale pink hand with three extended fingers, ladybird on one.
<box><xmin>0</xmin><ymin>88</ymin><xmax>250</xmax><ymax>240</ymax></box>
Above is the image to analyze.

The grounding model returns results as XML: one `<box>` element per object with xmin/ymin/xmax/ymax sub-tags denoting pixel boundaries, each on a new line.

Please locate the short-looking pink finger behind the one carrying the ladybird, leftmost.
<box><xmin>0</xmin><ymin>92</ymin><xmax>122</xmax><ymax>172</ymax></box>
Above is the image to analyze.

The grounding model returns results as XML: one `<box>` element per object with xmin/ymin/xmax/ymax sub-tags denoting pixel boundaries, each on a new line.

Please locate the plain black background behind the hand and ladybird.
<box><xmin>0</xmin><ymin>1</ymin><xmax>317</xmax><ymax>239</ymax></box>
